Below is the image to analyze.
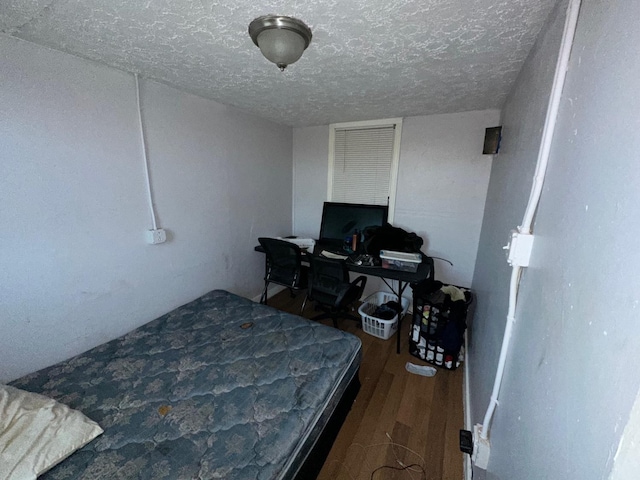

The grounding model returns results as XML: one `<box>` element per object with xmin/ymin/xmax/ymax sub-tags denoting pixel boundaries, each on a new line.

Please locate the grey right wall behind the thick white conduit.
<box><xmin>469</xmin><ymin>1</ymin><xmax>640</xmax><ymax>480</ymax></box>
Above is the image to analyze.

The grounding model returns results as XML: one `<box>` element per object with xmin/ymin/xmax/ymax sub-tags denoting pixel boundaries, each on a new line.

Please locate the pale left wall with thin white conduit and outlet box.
<box><xmin>0</xmin><ymin>36</ymin><xmax>292</xmax><ymax>381</ymax></box>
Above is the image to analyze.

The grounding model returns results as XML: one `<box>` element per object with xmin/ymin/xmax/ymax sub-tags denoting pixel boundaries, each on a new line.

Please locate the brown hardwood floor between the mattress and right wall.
<box><xmin>269</xmin><ymin>291</ymin><xmax>464</xmax><ymax>480</ymax></box>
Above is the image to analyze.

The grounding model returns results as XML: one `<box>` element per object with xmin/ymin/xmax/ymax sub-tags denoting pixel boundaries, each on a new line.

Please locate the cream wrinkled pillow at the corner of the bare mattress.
<box><xmin>0</xmin><ymin>385</ymin><xmax>103</xmax><ymax>480</ymax></box>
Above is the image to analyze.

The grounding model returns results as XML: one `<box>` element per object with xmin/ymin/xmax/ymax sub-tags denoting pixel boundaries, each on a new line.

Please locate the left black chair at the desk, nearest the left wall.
<box><xmin>258</xmin><ymin>238</ymin><xmax>309</xmax><ymax>309</ymax></box>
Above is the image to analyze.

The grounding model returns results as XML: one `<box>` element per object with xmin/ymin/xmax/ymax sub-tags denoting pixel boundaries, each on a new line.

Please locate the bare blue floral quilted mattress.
<box><xmin>11</xmin><ymin>290</ymin><xmax>361</xmax><ymax>480</ymax></box>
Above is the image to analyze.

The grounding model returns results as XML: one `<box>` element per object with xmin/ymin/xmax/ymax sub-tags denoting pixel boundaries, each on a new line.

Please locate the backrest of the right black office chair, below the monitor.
<box><xmin>309</xmin><ymin>255</ymin><xmax>351</xmax><ymax>306</ymax></box>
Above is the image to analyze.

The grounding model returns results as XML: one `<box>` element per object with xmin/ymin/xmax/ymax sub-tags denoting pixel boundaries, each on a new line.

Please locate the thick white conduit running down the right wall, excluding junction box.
<box><xmin>480</xmin><ymin>0</ymin><xmax>581</xmax><ymax>440</ymax></box>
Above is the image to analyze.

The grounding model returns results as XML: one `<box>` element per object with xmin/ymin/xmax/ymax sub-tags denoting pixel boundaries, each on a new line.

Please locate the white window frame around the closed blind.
<box><xmin>327</xmin><ymin>118</ymin><xmax>402</xmax><ymax>223</ymax></box>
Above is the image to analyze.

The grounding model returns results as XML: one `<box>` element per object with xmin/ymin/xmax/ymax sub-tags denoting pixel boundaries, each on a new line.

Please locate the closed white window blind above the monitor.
<box><xmin>331</xmin><ymin>126</ymin><xmax>395</xmax><ymax>205</ymax></box>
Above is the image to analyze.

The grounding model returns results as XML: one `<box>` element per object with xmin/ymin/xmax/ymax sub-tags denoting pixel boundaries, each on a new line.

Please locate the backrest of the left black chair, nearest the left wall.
<box><xmin>258</xmin><ymin>237</ymin><xmax>302</xmax><ymax>288</ymax></box>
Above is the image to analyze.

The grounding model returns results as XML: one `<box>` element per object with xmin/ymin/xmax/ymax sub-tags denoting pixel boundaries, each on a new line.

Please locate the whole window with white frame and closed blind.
<box><xmin>327</xmin><ymin>118</ymin><xmax>402</xmax><ymax>222</ymax></box>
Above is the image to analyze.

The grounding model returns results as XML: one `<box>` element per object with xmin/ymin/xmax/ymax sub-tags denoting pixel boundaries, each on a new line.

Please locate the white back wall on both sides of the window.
<box><xmin>293</xmin><ymin>110</ymin><xmax>500</xmax><ymax>288</ymax></box>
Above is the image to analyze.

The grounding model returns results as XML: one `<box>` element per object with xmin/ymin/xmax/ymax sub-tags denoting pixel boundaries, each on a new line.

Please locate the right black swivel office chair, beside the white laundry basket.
<box><xmin>302</xmin><ymin>255</ymin><xmax>367</xmax><ymax>328</ymax></box>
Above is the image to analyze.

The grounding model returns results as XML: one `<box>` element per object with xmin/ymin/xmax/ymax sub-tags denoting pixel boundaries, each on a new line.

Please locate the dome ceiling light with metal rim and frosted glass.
<box><xmin>249</xmin><ymin>15</ymin><xmax>311</xmax><ymax>71</ymax></box>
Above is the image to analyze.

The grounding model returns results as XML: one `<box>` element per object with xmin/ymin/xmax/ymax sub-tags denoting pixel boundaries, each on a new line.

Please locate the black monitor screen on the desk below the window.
<box><xmin>320</xmin><ymin>202</ymin><xmax>389</xmax><ymax>243</ymax></box>
